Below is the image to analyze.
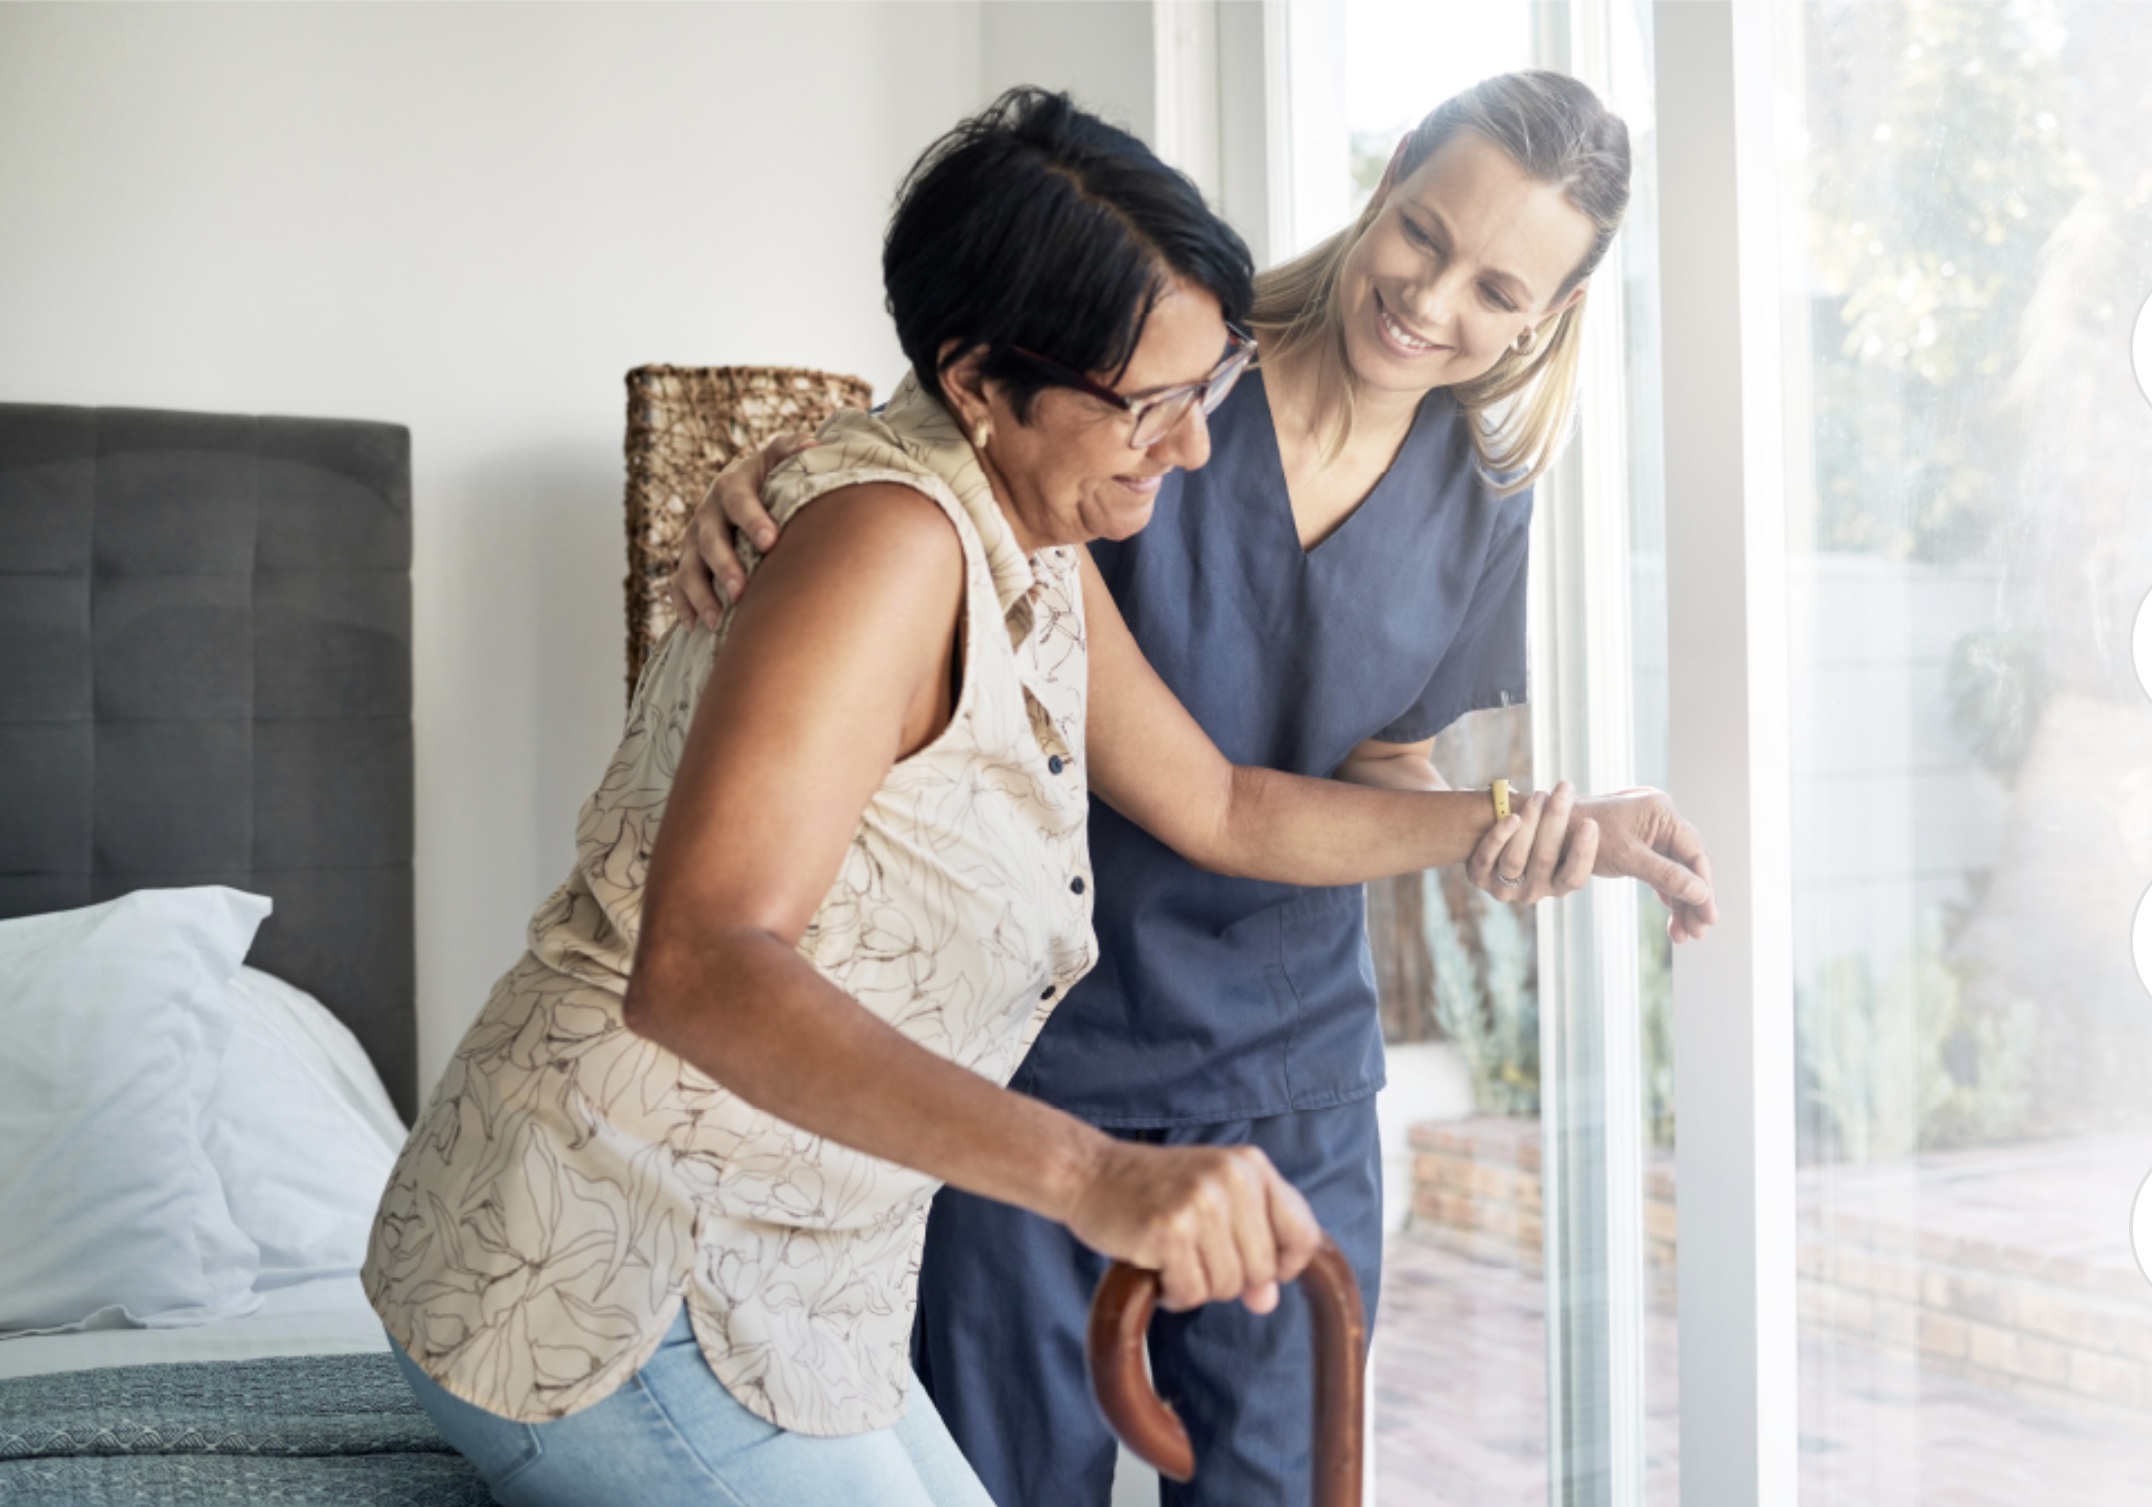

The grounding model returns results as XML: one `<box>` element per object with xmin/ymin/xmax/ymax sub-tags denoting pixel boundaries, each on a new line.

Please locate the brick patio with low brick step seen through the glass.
<box><xmin>1375</xmin><ymin>1119</ymin><xmax>2152</xmax><ymax>1507</ymax></box>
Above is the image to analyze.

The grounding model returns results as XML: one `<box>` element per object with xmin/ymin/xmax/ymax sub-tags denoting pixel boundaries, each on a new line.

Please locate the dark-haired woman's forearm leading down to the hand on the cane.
<box><xmin>622</xmin><ymin>928</ymin><xmax>1108</xmax><ymax>1221</ymax></box>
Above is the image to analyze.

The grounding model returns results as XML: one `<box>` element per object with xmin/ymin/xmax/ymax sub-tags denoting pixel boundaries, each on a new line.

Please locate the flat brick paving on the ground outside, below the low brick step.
<box><xmin>1375</xmin><ymin>1234</ymin><xmax>2152</xmax><ymax>1507</ymax></box>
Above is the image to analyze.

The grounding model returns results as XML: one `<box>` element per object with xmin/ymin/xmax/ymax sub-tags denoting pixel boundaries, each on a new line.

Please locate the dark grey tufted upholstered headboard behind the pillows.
<box><xmin>0</xmin><ymin>405</ymin><xmax>417</xmax><ymax>1117</ymax></box>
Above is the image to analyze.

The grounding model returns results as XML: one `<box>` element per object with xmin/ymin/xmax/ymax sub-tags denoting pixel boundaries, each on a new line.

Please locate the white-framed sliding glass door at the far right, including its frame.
<box><xmin>1655</xmin><ymin>0</ymin><xmax>2152</xmax><ymax>1507</ymax></box>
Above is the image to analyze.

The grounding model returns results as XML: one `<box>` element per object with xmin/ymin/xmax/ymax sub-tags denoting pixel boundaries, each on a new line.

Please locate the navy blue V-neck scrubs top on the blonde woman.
<box><xmin>1014</xmin><ymin>372</ymin><xmax>1532</xmax><ymax>1126</ymax></box>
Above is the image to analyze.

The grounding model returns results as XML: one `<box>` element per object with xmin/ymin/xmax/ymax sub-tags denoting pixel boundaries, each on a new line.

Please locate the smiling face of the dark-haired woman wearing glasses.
<box><xmin>943</xmin><ymin>280</ymin><xmax>1227</xmax><ymax>553</ymax></box>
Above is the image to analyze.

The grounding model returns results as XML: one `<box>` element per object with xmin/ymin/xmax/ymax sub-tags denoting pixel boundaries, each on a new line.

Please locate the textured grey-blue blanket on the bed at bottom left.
<box><xmin>0</xmin><ymin>1354</ymin><xmax>491</xmax><ymax>1507</ymax></box>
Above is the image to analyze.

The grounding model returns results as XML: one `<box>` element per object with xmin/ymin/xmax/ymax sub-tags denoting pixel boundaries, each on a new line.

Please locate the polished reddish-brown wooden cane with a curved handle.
<box><xmin>1087</xmin><ymin>1236</ymin><xmax>1367</xmax><ymax>1507</ymax></box>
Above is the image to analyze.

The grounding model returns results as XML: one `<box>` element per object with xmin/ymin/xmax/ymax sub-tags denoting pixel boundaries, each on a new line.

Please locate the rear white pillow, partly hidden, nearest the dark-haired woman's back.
<box><xmin>202</xmin><ymin>969</ymin><xmax>405</xmax><ymax>1287</ymax></box>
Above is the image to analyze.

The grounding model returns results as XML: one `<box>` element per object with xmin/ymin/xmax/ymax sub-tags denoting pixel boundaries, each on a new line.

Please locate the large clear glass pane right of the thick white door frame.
<box><xmin>1782</xmin><ymin>0</ymin><xmax>2152</xmax><ymax>1507</ymax></box>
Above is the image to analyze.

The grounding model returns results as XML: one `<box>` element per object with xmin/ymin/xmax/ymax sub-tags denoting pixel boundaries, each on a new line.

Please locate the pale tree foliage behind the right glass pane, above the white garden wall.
<box><xmin>1806</xmin><ymin>0</ymin><xmax>2090</xmax><ymax>560</ymax></box>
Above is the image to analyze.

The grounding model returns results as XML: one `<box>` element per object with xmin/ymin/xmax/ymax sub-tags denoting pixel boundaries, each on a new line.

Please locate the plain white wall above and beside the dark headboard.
<box><xmin>0</xmin><ymin>0</ymin><xmax>981</xmax><ymax>1085</ymax></box>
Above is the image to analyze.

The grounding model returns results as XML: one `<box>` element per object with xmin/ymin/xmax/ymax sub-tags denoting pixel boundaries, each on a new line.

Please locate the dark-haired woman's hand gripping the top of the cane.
<box><xmin>1065</xmin><ymin>1139</ymin><xmax>1323</xmax><ymax>1313</ymax></box>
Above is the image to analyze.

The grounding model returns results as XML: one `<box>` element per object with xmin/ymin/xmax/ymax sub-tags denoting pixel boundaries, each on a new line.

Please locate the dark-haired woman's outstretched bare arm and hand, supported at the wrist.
<box><xmin>1082</xmin><ymin>546</ymin><xmax>1717</xmax><ymax>936</ymax></box>
